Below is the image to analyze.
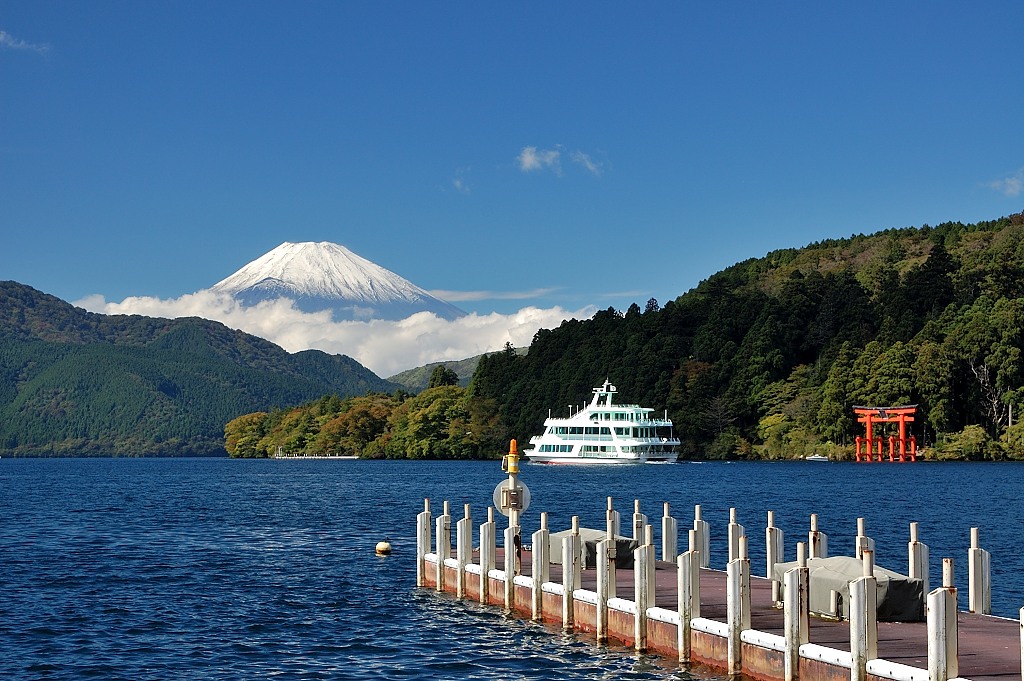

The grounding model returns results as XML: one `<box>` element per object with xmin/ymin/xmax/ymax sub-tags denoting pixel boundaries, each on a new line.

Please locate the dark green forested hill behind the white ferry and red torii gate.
<box><xmin>470</xmin><ymin>209</ymin><xmax>1024</xmax><ymax>459</ymax></box>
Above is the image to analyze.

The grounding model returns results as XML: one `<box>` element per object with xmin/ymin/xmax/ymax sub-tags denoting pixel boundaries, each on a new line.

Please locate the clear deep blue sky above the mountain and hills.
<box><xmin>0</xmin><ymin>0</ymin><xmax>1024</xmax><ymax>372</ymax></box>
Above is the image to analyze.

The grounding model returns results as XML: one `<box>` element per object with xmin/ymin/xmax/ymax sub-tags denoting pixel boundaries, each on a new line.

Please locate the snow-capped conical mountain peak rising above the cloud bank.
<box><xmin>209</xmin><ymin>242</ymin><xmax>466</xmax><ymax>322</ymax></box>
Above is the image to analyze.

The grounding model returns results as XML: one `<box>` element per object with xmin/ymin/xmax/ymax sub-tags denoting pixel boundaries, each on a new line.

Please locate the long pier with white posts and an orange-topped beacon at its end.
<box><xmin>417</xmin><ymin>448</ymin><xmax>1024</xmax><ymax>681</ymax></box>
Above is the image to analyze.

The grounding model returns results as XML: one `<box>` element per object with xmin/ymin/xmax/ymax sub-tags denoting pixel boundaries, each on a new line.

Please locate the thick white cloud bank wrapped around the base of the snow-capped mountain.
<box><xmin>75</xmin><ymin>291</ymin><xmax>594</xmax><ymax>378</ymax></box>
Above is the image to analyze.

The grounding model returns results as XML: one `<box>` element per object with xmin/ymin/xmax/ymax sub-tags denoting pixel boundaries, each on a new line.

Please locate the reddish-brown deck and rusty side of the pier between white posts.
<box><xmin>423</xmin><ymin>548</ymin><xmax>1022</xmax><ymax>681</ymax></box>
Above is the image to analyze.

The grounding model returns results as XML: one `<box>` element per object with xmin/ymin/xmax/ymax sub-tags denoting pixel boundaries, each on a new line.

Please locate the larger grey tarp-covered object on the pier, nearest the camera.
<box><xmin>772</xmin><ymin>556</ymin><xmax>925</xmax><ymax>622</ymax></box>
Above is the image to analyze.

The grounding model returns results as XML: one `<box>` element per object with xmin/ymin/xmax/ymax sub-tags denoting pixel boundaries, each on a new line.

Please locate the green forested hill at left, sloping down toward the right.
<box><xmin>0</xmin><ymin>282</ymin><xmax>397</xmax><ymax>456</ymax></box>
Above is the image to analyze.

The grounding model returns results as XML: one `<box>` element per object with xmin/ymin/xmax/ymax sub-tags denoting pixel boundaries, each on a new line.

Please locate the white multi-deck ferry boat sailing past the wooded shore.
<box><xmin>523</xmin><ymin>380</ymin><xmax>679</xmax><ymax>464</ymax></box>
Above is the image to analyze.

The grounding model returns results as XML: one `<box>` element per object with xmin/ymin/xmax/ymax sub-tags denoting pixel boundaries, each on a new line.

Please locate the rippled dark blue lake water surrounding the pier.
<box><xmin>0</xmin><ymin>459</ymin><xmax>1024</xmax><ymax>680</ymax></box>
